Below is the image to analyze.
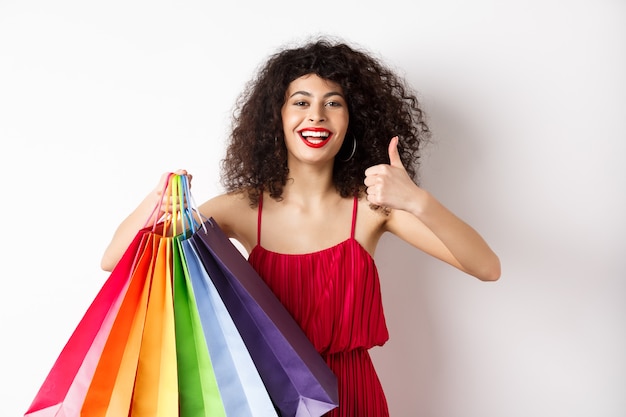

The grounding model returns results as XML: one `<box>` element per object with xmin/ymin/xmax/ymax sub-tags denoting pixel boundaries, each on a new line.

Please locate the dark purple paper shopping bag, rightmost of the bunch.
<box><xmin>190</xmin><ymin>219</ymin><xmax>338</xmax><ymax>417</ymax></box>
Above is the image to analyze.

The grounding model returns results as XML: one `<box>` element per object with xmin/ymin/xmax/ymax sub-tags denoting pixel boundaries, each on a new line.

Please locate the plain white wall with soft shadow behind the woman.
<box><xmin>0</xmin><ymin>0</ymin><xmax>626</xmax><ymax>417</ymax></box>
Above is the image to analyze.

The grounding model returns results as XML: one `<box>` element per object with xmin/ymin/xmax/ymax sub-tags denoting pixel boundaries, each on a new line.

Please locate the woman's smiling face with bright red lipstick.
<box><xmin>281</xmin><ymin>74</ymin><xmax>349</xmax><ymax>162</ymax></box>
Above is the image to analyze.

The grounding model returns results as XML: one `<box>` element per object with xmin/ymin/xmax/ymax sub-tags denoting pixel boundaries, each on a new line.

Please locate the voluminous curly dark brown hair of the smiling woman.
<box><xmin>221</xmin><ymin>38</ymin><xmax>430</xmax><ymax>207</ymax></box>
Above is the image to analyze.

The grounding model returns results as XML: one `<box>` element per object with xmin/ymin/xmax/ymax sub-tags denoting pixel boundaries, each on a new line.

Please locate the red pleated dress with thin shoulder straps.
<box><xmin>248</xmin><ymin>198</ymin><xmax>389</xmax><ymax>417</ymax></box>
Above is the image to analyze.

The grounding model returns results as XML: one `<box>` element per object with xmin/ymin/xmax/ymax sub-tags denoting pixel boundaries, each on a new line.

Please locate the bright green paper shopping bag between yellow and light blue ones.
<box><xmin>172</xmin><ymin>236</ymin><xmax>227</xmax><ymax>417</ymax></box>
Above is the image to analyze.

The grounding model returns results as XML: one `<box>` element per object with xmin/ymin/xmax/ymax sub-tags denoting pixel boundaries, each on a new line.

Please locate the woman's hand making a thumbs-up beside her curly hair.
<box><xmin>364</xmin><ymin>136</ymin><xmax>421</xmax><ymax>211</ymax></box>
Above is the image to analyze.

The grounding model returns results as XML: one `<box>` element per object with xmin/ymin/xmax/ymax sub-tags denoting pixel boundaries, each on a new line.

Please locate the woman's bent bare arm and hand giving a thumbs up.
<box><xmin>365</xmin><ymin>138</ymin><xmax>501</xmax><ymax>281</ymax></box>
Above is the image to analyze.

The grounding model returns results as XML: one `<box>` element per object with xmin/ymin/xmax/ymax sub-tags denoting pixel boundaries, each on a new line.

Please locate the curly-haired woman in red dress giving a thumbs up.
<box><xmin>102</xmin><ymin>39</ymin><xmax>500</xmax><ymax>417</ymax></box>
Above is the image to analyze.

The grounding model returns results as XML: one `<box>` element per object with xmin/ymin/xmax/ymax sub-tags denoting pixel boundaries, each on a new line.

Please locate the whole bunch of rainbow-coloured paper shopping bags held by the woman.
<box><xmin>26</xmin><ymin>175</ymin><xmax>337</xmax><ymax>417</ymax></box>
